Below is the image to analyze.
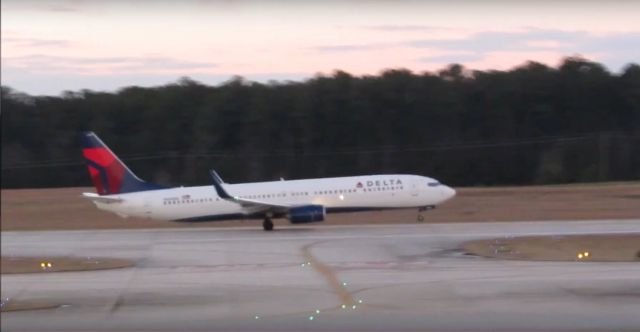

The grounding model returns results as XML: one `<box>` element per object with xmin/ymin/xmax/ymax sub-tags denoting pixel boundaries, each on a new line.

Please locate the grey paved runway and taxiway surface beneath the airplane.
<box><xmin>1</xmin><ymin>219</ymin><xmax>640</xmax><ymax>331</ymax></box>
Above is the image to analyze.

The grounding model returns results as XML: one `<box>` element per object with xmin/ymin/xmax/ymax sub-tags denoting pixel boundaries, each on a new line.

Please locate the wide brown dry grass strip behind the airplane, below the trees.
<box><xmin>0</xmin><ymin>182</ymin><xmax>640</xmax><ymax>231</ymax></box>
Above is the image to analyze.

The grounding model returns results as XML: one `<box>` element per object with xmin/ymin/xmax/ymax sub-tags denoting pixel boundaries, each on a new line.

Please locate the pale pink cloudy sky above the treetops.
<box><xmin>0</xmin><ymin>0</ymin><xmax>640</xmax><ymax>95</ymax></box>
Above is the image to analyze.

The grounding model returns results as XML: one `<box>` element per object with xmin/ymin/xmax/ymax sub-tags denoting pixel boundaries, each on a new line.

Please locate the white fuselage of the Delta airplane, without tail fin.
<box><xmin>95</xmin><ymin>174</ymin><xmax>455</xmax><ymax>221</ymax></box>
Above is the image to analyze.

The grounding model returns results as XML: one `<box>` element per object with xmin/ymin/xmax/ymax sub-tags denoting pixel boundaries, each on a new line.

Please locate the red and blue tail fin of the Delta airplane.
<box><xmin>80</xmin><ymin>132</ymin><xmax>164</xmax><ymax>195</ymax></box>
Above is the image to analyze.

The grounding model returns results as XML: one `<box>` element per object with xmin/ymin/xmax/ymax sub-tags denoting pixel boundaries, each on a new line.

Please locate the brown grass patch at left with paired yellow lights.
<box><xmin>0</xmin><ymin>256</ymin><xmax>135</xmax><ymax>274</ymax></box>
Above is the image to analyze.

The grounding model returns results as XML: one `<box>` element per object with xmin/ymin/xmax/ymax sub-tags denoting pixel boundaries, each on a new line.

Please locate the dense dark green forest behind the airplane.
<box><xmin>1</xmin><ymin>57</ymin><xmax>640</xmax><ymax>188</ymax></box>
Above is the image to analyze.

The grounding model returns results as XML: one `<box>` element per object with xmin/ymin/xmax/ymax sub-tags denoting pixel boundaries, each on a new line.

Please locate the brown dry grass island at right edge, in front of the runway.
<box><xmin>462</xmin><ymin>234</ymin><xmax>640</xmax><ymax>262</ymax></box>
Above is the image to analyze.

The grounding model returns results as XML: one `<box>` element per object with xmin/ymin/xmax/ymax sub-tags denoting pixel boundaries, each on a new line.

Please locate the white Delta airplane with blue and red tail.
<box><xmin>81</xmin><ymin>132</ymin><xmax>456</xmax><ymax>231</ymax></box>
